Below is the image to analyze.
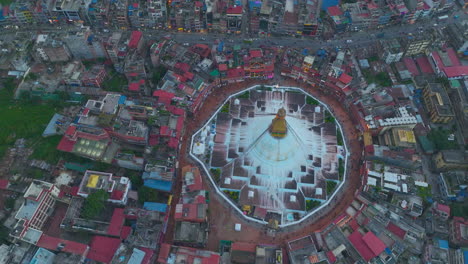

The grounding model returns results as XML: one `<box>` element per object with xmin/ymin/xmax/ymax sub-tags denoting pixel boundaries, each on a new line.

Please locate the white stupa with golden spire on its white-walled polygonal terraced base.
<box><xmin>190</xmin><ymin>85</ymin><xmax>349</xmax><ymax>227</ymax></box>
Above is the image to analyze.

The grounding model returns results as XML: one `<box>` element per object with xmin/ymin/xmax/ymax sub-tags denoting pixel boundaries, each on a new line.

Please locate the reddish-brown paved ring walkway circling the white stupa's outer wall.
<box><xmin>165</xmin><ymin>80</ymin><xmax>362</xmax><ymax>251</ymax></box>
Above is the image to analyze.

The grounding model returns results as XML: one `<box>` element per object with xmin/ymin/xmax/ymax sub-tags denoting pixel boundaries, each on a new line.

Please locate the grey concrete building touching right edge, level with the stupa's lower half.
<box><xmin>432</xmin><ymin>150</ymin><xmax>468</xmax><ymax>171</ymax></box>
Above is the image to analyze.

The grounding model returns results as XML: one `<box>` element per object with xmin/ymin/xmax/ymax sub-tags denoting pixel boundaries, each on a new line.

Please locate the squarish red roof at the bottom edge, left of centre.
<box><xmin>87</xmin><ymin>236</ymin><xmax>120</xmax><ymax>263</ymax></box>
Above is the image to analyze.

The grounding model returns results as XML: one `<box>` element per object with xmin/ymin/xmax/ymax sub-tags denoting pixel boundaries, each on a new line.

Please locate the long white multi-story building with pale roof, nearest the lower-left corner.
<box><xmin>10</xmin><ymin>181</ymin><xmax>60</xmax><ymax>244</ymax></box>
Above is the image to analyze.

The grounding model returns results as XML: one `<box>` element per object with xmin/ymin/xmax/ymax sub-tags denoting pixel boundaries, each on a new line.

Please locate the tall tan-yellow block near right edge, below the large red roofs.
<box><xmin>423</xmin><ymin>83</ymin><xmax>455</xmax><ymax>124</ymax></box>
